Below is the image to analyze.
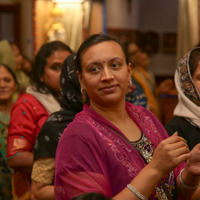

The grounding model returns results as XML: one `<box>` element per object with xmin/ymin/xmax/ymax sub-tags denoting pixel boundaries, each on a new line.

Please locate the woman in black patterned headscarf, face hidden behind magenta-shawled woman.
<box><xmin>31</xmin><ymin>54</ymin><xmax>83</xmax><ymax>200</ymax></box>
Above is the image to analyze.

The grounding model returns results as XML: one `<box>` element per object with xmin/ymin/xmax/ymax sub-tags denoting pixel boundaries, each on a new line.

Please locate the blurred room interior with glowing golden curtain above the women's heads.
<box><xmin>0</xmin><ymin>0</ymin><xmax>200</xmax><ymax>82</ymax></box>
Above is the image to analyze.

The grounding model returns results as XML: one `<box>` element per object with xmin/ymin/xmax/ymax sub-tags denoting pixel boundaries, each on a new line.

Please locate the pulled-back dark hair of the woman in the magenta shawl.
<box><xmin>75</xmin><ymin>33</ymin><xmax>129</xmax><ymax>73</ymax></box>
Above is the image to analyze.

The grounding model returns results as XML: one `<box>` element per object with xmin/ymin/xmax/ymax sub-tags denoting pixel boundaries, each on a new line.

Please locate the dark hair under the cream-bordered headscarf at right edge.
<box><xmin>189</xmin><ymin>47</ymin><xmax>200</xmax><ymax>77</ymax></box>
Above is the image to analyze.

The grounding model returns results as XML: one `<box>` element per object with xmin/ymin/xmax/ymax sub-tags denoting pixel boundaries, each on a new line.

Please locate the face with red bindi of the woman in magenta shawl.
<box><xmin>78</xmin><ymin>41</ymin><xmax>131</xmax><ymax>106</ymax></box>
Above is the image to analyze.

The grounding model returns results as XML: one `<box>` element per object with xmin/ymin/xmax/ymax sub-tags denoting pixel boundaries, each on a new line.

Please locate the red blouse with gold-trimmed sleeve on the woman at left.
<box><xmin>7</xmin><ymin>94</ymin><xmax>49</xmax><ymax>158</ymax></box>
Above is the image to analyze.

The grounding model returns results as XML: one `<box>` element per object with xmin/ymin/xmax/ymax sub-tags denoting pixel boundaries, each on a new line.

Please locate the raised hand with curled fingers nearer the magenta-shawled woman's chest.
<box><xmin>149</xmin><ymin>133</ymin><xmax>191</xmax><ymax>177</ymax></box>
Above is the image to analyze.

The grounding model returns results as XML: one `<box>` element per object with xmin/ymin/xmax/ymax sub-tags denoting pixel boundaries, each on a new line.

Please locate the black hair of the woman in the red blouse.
<box><xmin>30</xmin><ymin>41</ymin><xmax>72</xmax><ymax>93</ymax></box>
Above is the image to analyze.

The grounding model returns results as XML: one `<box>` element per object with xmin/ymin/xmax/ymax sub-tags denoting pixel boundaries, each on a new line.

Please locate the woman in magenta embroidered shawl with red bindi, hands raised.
<box><xmin>55</xmin><ymin>34</ymin><xmax>200</xmax><ymax>200</ymax></box>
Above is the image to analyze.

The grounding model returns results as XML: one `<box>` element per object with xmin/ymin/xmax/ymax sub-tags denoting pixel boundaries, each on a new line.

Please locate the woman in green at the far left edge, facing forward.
<box><xmin>0</xmin><ymin>64</ymin><xmax>17</xmax><ymax>200</ymax></box>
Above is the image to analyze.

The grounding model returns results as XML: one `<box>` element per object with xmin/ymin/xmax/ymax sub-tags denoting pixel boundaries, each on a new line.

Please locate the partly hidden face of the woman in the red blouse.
<box><xmin>41</xmin><ymin>50</ymin><xmax>71</xmax><ymax>93</ymax></box>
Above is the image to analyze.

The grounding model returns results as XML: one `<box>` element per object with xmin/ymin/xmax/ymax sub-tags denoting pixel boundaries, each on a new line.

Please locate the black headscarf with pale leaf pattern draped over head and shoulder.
<box><xmin>34</xmin><ymin>53</ymin><xmax>83</xmax><ymax>160</ymax></box>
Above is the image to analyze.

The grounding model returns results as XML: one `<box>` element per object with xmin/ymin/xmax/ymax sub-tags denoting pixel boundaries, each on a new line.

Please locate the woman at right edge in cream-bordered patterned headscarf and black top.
<box><xmin>165</xmin><ymin>47</ymin><xmax>200</xmax><ymax>149</ymax></box>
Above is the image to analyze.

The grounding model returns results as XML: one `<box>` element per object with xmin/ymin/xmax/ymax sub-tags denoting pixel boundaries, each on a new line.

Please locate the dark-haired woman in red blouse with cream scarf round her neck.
<box><xmin>7</xmin><ymin>41</ymin><xmax>72</xmax><ymax>200</ymax></box>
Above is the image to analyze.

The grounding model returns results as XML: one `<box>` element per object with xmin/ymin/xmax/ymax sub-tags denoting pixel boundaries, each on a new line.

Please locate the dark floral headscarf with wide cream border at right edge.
<box><xmin>174</xmin><ymin>48</ymin><xmax>200</xmax><ymax>127</ymax></box>
